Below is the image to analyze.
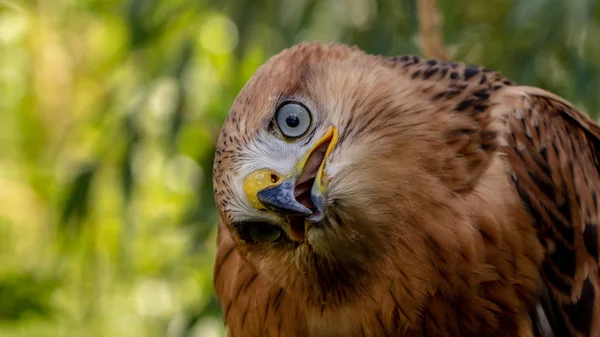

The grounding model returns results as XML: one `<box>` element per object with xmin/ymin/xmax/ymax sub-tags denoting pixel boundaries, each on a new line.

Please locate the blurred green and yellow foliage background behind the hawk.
<box><xmin>0</xmin><ymin>0</ymin><xmax>600</xmax><ymax>337</ymax></box>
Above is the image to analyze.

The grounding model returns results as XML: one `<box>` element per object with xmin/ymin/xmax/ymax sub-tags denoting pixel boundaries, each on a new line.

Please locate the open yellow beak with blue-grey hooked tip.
<box><xmin>244</xmin><ymin>126</ymin><xmax>338</xmax><ymax>241</ymax></box>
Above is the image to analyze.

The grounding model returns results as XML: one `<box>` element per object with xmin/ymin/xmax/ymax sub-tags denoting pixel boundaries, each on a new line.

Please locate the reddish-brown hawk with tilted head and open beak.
<box><xmin>214</xmin><ymin>43</ymin><xmax>600</xmax><ymax>337</ymax></box>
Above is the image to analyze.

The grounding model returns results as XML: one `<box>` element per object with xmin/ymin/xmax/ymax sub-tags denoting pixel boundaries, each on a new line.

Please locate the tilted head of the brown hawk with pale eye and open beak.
<box><xmin>215</xmin><ymin>44</ymin><xmax>458</xmax><ymax>300</ymax></box>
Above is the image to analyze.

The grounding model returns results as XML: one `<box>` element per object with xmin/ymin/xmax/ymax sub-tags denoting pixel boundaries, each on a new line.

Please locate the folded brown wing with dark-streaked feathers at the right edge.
<box><xmin>494</xmin><ymin>87</ymin><xmax>600</xmax><ymax>337</ymax></box>
